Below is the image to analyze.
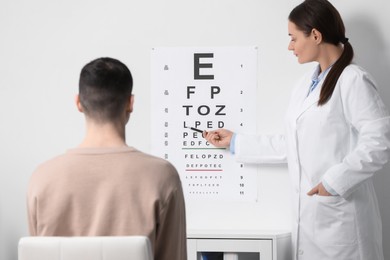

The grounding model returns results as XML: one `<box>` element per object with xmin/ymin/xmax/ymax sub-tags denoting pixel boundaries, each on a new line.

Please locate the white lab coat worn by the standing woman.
<box><xmin>235</xmin><ymin>65</ymin><xmax>390</xmax><ymax>260</ymax></box>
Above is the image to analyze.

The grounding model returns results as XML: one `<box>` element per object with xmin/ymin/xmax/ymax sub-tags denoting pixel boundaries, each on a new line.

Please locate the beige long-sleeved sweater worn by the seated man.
<box><xmin>27</xmin><ymin>147</ymin><xmax>187</xmax><ymax>260</ymax></box>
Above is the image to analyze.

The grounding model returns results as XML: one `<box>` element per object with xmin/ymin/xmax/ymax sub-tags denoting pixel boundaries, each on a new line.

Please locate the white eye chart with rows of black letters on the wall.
<box><xmin>151</xmin><ymin>47</ymin><xmax>257</xmax><ymax>201</ymax></box>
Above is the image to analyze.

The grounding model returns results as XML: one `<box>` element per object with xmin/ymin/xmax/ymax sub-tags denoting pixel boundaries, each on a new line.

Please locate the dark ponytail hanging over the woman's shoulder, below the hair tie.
<box><xmin>318</xmin><ymin>38</ymin><xmax>353</xmax><ymax>106</ymax></box>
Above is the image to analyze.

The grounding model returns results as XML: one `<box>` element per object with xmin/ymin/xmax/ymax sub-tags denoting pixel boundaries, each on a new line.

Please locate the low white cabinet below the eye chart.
<box><xmin>187</xmin><ymin>230</ymin><xmax>292</xmax><ymax>260</ymax></box>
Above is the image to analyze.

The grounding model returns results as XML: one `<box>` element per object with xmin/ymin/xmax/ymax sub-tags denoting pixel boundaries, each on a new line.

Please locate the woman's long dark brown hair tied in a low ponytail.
<box><xmin>288</xmin><ymin>0</ymin><xmax>353</xmax><ymax>106</ymax></box>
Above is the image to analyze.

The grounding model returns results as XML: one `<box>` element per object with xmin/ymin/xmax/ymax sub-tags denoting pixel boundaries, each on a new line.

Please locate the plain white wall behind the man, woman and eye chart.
<box><xmin>0</xmin><ymin>0</ymin><xmax>390</xmax><ymax>260</ymax></box>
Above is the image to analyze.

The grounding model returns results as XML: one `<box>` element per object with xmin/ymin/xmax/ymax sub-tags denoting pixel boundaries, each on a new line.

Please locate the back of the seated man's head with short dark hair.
<box><xmin>79</xmin><ymin>58</ymin><xmax>133</xmax><ymax>122</ymax></box>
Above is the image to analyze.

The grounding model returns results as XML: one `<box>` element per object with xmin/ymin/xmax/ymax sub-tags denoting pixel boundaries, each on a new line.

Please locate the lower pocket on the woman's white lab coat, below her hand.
<box><xmin>314</xmin><ymin>195</ymin><xmax>357</xmax><ymax>246</ymax></box>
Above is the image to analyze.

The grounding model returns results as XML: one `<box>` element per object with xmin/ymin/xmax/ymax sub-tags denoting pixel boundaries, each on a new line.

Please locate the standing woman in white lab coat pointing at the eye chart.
<box><xmin>204</xmin><ymin>0</ymin><xmax>390</xmax><ymax>260</ymax></box>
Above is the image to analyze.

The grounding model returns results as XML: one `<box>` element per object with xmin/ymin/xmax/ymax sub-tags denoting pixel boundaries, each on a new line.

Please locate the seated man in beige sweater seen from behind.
<box><xmin>27</xmin><ymin>58</ymin><xmax>187</xmax><ymax>260</ymax></box>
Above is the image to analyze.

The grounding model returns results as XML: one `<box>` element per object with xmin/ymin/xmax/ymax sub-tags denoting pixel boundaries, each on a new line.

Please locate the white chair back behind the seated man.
<box><xmin>18</xmin><ymin>236</ymin><xmax>153</xmax><ymax>260</ymax></box>
